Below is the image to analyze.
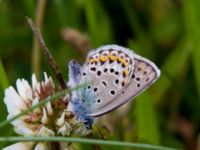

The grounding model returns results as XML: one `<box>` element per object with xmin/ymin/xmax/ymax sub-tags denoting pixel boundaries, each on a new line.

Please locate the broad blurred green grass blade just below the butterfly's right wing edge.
<box><xmin>135</xmin><ymin>91</ymin><xmax>161</xmax><ymax>144</ymax></box>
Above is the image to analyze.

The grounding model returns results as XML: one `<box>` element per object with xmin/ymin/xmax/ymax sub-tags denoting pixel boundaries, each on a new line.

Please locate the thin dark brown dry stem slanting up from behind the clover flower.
<box><xmin>26</xmin><ymin>17</ymin><xmax>67</xmax><ymax>89</ymax></box>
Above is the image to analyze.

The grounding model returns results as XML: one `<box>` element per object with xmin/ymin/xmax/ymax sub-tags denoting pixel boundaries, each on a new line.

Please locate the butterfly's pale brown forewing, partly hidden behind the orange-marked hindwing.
<box><xmin>89</xmin><ymin>54</ymin><xmax>160</xmax><ymax>117</ymax></box>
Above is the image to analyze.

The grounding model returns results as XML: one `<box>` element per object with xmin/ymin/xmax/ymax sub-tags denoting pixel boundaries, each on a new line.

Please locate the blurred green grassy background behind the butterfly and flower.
<box><xmin>0</xmin><ymin>0</ymin><xmax>200</xmax><ymax>150</ymax></box>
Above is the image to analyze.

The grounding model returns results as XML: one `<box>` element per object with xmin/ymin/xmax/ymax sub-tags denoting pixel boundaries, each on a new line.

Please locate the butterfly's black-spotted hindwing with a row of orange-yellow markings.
<box><xmin>79</xmin><ymin>45</ymin><xmax>134</xmax><ymax>114</ymax></box>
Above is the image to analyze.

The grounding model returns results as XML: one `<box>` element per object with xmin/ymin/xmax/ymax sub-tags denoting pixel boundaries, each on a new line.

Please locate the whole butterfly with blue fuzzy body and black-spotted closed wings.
<box><xmin>68</xmin><ymin>45</ymin><xmax>160</xmax><ymax>128</ymax></box>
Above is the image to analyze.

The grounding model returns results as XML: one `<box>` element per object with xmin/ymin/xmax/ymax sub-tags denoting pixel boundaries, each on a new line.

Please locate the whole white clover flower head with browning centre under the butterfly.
<box><xmin>4</xmin><ymin>73</ymin><xmax>90</xmax><ymax>150</ymax></box>
